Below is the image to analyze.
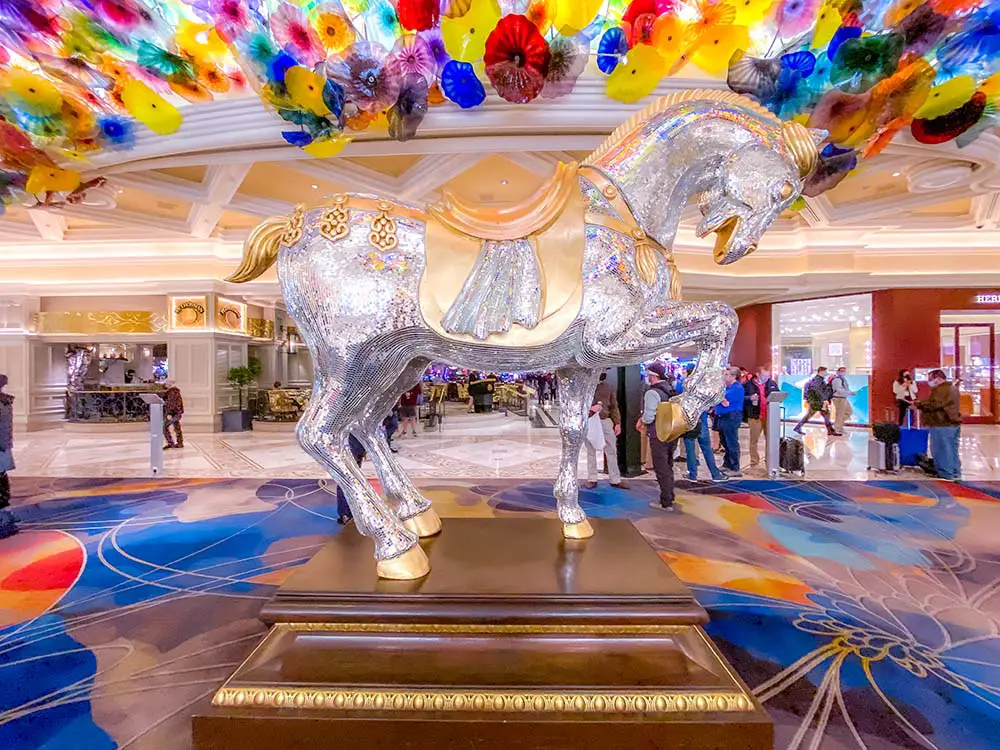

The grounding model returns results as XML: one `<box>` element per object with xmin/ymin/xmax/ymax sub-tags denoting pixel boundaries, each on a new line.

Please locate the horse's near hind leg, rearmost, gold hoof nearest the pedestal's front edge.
<box><xmin>296</xmin><ymin>375</ymin><xmax>430</xmax><ymax>580</ymax></box>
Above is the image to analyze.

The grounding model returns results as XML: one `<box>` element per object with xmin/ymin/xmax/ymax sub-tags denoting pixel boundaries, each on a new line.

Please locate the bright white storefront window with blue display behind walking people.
<box><xmin>771</xmin><ymin>294</ymin><xmax>872</xmax><ymax>424</ymax></box>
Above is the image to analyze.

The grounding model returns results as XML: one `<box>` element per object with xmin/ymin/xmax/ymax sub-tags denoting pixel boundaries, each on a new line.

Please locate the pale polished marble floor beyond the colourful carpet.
<box><xmin>15</xmin><ymin>411</ymin><xmax>1000</xmax><ymax>480</ymax></box>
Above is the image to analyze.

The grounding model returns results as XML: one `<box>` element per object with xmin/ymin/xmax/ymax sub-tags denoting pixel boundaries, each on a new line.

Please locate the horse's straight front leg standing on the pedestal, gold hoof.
<box><xmin>554</xmin><ymin>367</ymin><xmax>600</xmax><ymax>539</ymax></box>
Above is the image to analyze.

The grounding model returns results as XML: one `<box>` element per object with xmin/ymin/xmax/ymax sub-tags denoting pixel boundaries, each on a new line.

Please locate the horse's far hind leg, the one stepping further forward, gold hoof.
<box><xmin>357</xmin><ymin>359</ymin><xmax>441</xmax><ymax>537</ymax></box>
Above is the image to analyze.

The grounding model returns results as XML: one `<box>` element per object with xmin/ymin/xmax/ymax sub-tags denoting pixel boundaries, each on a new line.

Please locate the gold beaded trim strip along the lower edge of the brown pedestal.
<box><xmin>212</xmin><ymin>686</ymin><xmax>753</xmax><ymax>714</ymax></box>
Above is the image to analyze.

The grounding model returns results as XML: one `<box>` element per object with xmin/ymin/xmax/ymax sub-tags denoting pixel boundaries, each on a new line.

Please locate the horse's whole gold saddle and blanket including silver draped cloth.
<box><xmin>420</xmin><ymin>163</ymin><xmax>586</xmax><ymax>347</ymax></box>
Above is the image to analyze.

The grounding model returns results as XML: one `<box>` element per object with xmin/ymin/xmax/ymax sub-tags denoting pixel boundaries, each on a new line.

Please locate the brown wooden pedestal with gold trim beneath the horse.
<box><xmin>194</xmin><ymin>519</ymin><xmax>773</xmax><ymax>750</ymax></box>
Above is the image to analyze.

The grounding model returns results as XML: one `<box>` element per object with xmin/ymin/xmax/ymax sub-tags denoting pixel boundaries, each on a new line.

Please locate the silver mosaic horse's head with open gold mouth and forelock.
<box><xmin>697</xmin><ymin>122</ymin><xmax>825</xmax><ymax>265</ymax></box>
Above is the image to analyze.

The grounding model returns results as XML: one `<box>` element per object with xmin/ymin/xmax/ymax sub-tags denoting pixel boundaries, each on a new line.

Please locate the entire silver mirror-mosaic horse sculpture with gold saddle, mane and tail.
<box><xmin>230</xmin><ymin>91</ymin><xmax>820</xmax><ymax>579</ymax></box>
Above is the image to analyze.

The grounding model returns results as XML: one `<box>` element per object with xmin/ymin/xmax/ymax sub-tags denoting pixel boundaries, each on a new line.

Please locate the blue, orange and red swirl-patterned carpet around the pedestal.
<box><xmin>0</xmin><ymin>477</ymin><xmax>1000</xmax><ymax>750</ymax></box>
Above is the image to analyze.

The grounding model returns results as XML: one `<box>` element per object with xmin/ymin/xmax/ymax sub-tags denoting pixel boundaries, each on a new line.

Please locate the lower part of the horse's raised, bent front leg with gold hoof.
<box><xmin>671</xmin><ymin>302</ymin><xmax>744</xmax><ymax>439</ymax></box>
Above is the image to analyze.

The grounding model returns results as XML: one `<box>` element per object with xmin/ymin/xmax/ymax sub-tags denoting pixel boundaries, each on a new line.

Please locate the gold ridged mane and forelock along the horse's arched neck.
<box><xmin>584</xmin><ymin>89</ymin><xmax>819</xmax><ymax>177</ymax></box>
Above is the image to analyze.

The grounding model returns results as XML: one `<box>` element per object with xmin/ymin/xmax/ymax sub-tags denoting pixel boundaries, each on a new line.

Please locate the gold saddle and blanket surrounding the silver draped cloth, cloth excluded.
<box><xmin>420</xmin><ymin>163</ymin><xmax>586</xmax><ymax>347</ymax></box>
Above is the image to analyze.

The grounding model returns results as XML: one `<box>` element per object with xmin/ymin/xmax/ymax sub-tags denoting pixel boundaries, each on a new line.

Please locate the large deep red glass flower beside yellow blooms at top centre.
<box><xmin>483</xmin><ymin>15</ymin><xmax>551</xmax><ymax>103</ymax></box>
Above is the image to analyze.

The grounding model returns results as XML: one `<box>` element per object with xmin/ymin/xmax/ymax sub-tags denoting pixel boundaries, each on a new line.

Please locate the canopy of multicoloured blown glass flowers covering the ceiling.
<box><xmin>0</xmin><ymin>0</ymin><xmax>1000</xmax><ymax>209</ymax></box>
